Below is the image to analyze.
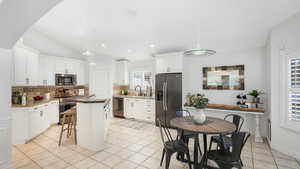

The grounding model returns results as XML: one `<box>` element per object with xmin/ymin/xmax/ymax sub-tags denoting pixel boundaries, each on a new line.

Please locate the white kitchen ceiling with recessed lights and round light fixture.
<box><xmin>33</xmin><ymin>0</ymin><xmax>300</xmax><ymax>60</ymax></box>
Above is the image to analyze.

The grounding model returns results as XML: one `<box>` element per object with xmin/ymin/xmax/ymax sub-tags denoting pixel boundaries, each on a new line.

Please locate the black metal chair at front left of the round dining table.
<box><xmin>157</xmin><ymin>119</ymin><xmax>192</xmax><ymax>169</ymax></box>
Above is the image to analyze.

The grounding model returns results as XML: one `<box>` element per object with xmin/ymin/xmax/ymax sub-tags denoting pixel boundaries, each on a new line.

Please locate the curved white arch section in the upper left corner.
<box><xmin>0</xmin><ymin>0</ymin><xmax>61</xmax><ymax>49</ymax></box>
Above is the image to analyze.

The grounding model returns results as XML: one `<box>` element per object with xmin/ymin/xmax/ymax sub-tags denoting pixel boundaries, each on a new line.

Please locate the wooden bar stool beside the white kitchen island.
<box><xmin>58</xmin><ymin>107</ymin><xmax>77</xmax><ymax>146</ymax></box>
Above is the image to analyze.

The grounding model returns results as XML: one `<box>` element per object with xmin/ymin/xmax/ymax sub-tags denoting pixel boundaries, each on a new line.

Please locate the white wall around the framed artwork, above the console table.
<box><xmin>183</xmin><ymin>48</ymin><xmax>266</xmax><ymax>105</ymax></box>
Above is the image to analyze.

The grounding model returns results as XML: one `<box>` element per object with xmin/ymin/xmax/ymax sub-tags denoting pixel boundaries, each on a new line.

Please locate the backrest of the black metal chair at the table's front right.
<box><xmin>231</xmin><ymin>132</ymin><xmax>250</xmax><ymax>161</ymax></box>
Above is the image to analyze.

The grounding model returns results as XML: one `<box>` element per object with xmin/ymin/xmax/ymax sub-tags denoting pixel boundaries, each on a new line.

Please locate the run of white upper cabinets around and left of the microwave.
<box><xmin>13</xmin><ymin>43</ymin><xmax>87</xmax><ymax>86</ymax></box>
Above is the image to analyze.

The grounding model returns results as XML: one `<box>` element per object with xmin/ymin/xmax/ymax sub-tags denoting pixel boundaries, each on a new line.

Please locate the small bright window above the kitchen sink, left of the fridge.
<box><xmin>130</xmin><ymin>71</ymin><xmax>153</xmax><ymax>90</ymax></box>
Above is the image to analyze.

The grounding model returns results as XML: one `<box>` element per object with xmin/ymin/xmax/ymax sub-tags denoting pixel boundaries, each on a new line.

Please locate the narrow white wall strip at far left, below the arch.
<box><xmin>0</xmin><ymin>48</ymin><xmax>12</xmax><ymax>169</ymax></box>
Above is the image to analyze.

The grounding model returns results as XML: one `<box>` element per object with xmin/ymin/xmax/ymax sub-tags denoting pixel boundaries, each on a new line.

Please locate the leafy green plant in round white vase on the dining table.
<box><xmin>185</xmin><ymin>93</ymin><xmax>208</xmax><ymax>124</ymax></box>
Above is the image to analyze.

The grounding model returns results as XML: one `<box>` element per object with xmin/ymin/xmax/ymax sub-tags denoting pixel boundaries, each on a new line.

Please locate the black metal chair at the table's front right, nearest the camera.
<box><xmin>206</xmin><ymin>132</ymin><xmax>250</xmax><ymax>169</ymax></box>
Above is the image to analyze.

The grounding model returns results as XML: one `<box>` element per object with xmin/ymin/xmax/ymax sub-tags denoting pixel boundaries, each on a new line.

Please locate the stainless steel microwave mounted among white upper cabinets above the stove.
<box><xmin>55</xmin><ymin>74</ymin><xmax>77</xmax><ymax>86</ymax></box>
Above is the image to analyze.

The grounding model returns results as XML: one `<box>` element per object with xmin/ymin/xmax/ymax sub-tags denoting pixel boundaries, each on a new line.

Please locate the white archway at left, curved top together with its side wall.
<box><xmin>0</xmin><ymin>0</ymin><xmax>61</xmax><ymax>169</ymax></box>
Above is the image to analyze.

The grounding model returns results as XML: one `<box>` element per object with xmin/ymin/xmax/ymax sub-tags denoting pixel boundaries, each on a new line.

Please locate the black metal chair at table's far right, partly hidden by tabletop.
<box><xmin>209</xmin><ymin>114</ymin><xmax>245</xmax><ymax>150</ymax></box>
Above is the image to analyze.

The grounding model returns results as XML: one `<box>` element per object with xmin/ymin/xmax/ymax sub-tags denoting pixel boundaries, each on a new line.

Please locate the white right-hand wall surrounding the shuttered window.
<box><xmin>268</xmin><ymin>13</ymin><xmax>300</xmax><ymax>159</ymax></box>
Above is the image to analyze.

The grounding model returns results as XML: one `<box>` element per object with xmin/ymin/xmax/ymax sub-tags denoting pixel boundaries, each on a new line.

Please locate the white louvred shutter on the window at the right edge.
<box><xmin>288</xmin><ymin>59</ymin><xmax>300</xmax><ymax>122</ymax></box>
